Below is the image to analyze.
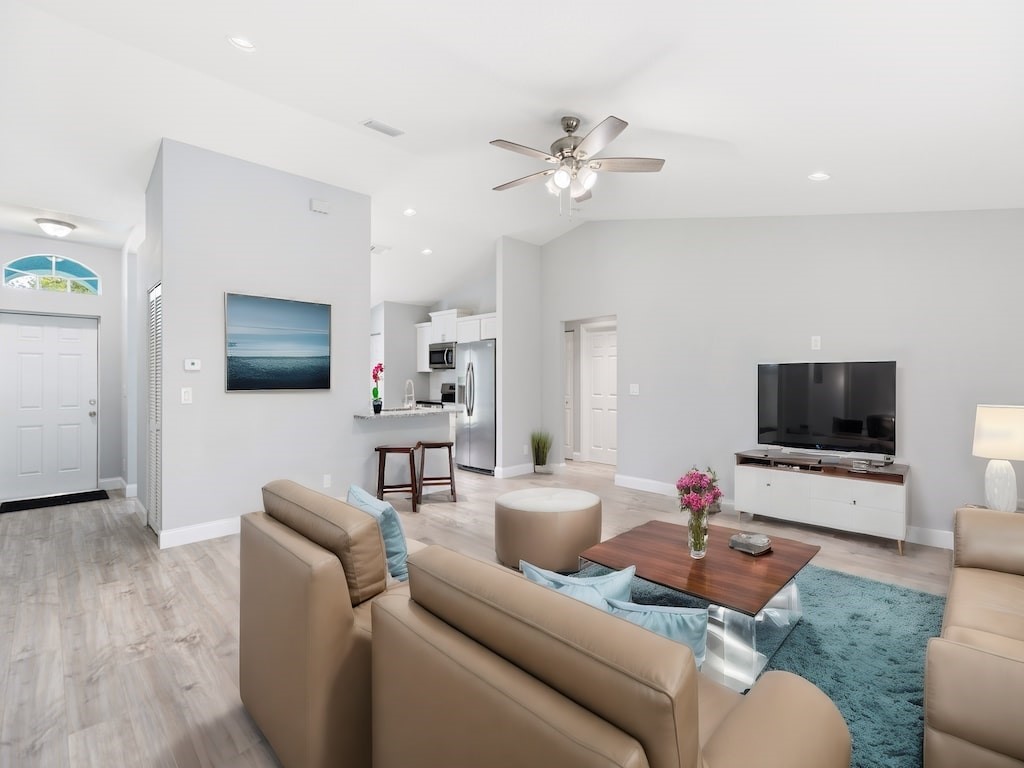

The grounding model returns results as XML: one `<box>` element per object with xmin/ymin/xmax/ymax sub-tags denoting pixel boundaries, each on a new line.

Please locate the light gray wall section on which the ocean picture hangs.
<box><xmin>139</xmin><ymin>139</ymin><xmax>372</xmax><ymax>530</ymax></box>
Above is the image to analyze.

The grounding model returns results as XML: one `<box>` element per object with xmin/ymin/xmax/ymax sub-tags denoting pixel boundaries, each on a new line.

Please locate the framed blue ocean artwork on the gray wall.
<box><xmin>224</xmin><ymin>293</ymin><xmax>331</xmax><ymax>392</ymax></box>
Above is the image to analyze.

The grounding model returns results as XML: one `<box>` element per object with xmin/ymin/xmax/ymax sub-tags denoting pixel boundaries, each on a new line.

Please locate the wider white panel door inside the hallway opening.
<box><xmin>581</xmin><ymin>329</ymin><xmax>618</xmax><ymax>464</ymax></box>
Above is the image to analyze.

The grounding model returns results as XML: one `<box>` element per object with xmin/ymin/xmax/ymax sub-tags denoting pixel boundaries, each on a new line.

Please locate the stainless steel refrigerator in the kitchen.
<box><xmin>455</xmin><ymin>339</ymin><xmax>498</xmax><ymax>474</ymax></box>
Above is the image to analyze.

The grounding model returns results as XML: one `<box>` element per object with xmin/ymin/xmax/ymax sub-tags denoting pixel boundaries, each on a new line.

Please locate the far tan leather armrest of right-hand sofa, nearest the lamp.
<box><xmin>953</xmin><ymin>507</ymin><xmax>1024</xmax><ymax>575</ymax></box>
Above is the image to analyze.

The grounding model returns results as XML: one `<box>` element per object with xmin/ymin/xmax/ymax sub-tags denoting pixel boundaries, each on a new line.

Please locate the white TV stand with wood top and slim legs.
<box><xmin>734</xmin><ymin>450</ymin><xmax>910</xmax><ymax>555</ymax></box>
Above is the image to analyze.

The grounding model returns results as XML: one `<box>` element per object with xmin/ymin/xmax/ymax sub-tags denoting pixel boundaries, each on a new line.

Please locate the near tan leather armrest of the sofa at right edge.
<box><xmin>925</xmin><ymin>638</ymin><xmax>1024</xmax><ymax>765</ymax></box>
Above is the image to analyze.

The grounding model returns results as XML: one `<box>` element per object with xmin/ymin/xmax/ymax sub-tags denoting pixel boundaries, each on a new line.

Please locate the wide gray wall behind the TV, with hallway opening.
<box><xmin>540</xmin><ymin>210</ymin><xmax>1024</xmax><ymax>541</ymax></box>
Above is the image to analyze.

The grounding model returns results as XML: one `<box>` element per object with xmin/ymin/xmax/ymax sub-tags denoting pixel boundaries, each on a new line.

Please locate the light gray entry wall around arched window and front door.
<box><xmin>0</xmin><ymin>231</ymin><xmax>126</xmax><ymax>487</ymax></box>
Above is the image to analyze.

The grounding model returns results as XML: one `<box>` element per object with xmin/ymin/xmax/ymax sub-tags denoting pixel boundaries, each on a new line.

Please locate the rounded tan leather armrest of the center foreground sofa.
<box><xmin>703</xmin><ymin>672</ymin><xmax>852</xmax><ymax>768</ymax></box>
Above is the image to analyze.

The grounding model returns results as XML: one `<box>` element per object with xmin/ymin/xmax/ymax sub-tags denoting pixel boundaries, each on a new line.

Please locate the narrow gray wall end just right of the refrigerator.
<box><xmin>496</xmin><ymin>238</ymin><xmax>544</xmax><ymax>475</ymax></box>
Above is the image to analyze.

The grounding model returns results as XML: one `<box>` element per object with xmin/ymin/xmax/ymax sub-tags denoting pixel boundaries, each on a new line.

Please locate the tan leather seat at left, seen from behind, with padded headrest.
<box><xmin>239</xmin><ymin>480</ymin><xmax>422</xmax><ymax>768</ymax></box>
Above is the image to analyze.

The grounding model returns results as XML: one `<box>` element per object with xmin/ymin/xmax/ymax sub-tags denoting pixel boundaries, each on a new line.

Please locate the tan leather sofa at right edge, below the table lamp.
<box><xmin>925</xmin><ymin>507</ymin><xmax>1024</xmax><ymax>768</ymax></box>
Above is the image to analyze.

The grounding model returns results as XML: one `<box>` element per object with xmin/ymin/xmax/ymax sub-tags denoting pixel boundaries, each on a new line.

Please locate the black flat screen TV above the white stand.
<box><xmin>758</xmin><ymin>360</ymin><xmax>896</xmax><ymax>456</ymax></box>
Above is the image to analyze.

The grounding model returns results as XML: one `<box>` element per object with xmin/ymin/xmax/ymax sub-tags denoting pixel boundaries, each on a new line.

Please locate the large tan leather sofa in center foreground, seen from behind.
<box><xmin>372</xmin><ymin>546</ymin><xmax>850</xmax><ymax>768</ymax></box>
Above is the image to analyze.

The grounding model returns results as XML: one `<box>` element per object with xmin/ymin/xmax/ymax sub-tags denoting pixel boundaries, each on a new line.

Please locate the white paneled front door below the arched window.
<box><xmin>0</xmin><ymin>312</ymin><xmax>98</xmax><ymax>500</ymax></box>
